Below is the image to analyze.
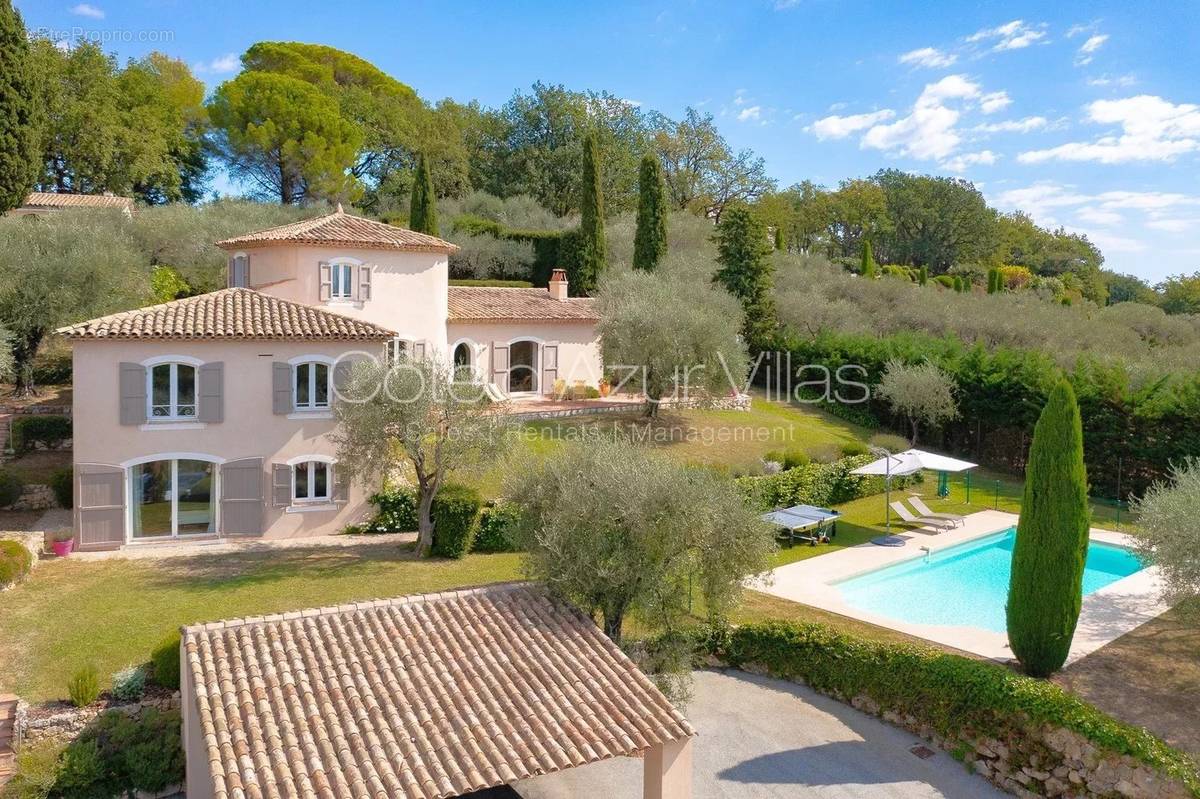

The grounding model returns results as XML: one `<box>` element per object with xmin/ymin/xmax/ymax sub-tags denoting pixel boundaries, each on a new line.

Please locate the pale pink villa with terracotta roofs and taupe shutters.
<box><xmin>59</xmin><ymin>206</ymin><xmax>602</xmax><ymax>549</ymax></box>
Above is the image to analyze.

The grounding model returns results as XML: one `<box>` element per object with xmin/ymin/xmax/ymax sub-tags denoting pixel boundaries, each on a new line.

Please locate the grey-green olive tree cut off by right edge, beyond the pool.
<box><xmin>1130</xmin><ymin>457</ymin><xmax>1200</xmax><ymax>609</ymax></box>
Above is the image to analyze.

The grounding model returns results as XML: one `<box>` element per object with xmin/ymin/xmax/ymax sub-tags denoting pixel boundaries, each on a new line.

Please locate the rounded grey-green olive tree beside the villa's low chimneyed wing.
<box><xmin>599</xmin><ymin>271</ymin><xmax>749</xmax><ymax>417</ymax></box>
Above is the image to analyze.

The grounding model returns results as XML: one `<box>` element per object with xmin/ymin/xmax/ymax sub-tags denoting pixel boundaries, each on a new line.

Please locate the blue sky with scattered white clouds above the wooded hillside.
<box><xmin>16</xmin><ymin>0</ymin><xmax>1200</xmax><ymax>283</ymax></box>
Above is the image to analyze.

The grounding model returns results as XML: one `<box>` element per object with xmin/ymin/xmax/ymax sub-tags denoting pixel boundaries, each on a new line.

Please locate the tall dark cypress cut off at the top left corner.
<box><xmin>0</xmin><ymin>0</ymin><xmax>38</xmax><ymax>214</ymax></box>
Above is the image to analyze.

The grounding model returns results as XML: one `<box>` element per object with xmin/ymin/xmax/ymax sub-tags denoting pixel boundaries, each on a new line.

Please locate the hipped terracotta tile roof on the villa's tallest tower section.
<box><xmin>217</xmin><ymin>205</ymin><xmax>458</xmax><ymax>253</ymax></box>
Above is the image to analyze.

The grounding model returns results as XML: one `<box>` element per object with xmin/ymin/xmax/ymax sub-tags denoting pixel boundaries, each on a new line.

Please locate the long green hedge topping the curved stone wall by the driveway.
<box><xmin>696</xmin><ymin>621</ymin><xmax>1200</xmax><ymax>797</ymax></box>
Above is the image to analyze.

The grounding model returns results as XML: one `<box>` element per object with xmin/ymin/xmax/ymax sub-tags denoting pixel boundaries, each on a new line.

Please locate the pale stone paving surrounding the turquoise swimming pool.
<box><xmin>751</xmin><ymin>511</ymin><xmax>1169</xmax><ymax>663</ymax></box>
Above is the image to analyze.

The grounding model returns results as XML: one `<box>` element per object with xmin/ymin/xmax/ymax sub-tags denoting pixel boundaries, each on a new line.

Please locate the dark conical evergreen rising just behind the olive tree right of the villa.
<box><xmin>713</xmin><ymin>203</ymin><xmax>776</xmax><ymax>353</ymax></box>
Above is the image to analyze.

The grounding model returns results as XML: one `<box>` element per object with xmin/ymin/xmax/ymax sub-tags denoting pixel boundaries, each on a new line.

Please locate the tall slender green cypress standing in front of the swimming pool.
<box><xmin>1006</xmin><ymin>380</ymin><xmax>1090</xmax><ymax>677</ymax></box>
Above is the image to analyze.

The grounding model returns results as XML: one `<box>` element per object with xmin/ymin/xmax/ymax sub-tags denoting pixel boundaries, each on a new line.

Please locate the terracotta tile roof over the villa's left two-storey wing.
<box><xmin>58</xmin><ymin>288</ymin><xmax>396</xmax><ymax>341</ymax></box>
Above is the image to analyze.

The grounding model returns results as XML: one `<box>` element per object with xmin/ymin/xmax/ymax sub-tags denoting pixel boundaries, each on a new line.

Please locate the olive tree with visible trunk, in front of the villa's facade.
<box><xmin>331</xmin><ymin>358</ymin><xmax>505</xmax><ymax>557</ymax></box>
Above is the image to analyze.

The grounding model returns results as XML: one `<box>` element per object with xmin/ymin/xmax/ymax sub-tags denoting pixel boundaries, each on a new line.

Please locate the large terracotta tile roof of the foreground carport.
<box><xmin>182</xmin><ymin>584</ymin><xmax>695</xmax><ymax>799</ymax></box>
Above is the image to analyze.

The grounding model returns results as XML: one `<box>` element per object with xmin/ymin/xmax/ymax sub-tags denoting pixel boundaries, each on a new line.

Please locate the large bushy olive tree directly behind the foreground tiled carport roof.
<box><xmin>504</xmin><ymin>439</ymin><xmax>775</xmax><ymax>643</ymax></box>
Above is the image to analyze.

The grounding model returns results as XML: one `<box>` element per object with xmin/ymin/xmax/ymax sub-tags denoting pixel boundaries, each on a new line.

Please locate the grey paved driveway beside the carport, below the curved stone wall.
<box><xmin>516</xmin><ymin>671</ymin><xmax>1007</xmax><ymax>799</ymax></box>
